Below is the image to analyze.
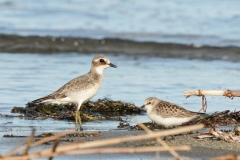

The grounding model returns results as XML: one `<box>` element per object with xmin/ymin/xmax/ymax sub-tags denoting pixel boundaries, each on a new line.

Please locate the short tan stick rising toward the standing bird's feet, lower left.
<box><xmin>4</xmin><ymin>129</ymin><xmax>75</xmax><ymax>157</ymax></box>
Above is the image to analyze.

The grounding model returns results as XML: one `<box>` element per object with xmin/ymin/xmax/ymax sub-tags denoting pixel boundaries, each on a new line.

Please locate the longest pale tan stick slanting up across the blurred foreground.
<box><xmin>4</xmin><ymin>124</ymin><xmax>204</xmax><ymax>160</ymax></box>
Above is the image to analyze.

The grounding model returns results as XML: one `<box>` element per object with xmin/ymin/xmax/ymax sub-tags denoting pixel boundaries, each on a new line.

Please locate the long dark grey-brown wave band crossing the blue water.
<box><xmin>0</xmin><ymin>34</ymin><xmax>240</xmax><ymax>62</ymax></box>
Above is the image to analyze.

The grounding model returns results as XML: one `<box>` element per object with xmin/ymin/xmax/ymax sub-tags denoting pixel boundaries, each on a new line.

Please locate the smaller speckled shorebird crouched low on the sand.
<box><xmin>144</xmin><ymin>97</ymin><xmax>205</xmax><ymax>127</ymax></box>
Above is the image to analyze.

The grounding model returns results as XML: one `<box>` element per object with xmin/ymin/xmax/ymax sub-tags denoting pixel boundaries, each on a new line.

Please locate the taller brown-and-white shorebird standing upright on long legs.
<box><xmin>32</xmin><ymin>56</ymin><xmax>117</xmax><ymax>131</ymax></box>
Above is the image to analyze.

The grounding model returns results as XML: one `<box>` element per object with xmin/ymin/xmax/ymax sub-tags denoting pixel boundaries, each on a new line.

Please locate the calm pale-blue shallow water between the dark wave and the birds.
<box><xmin>0</xmin><ymin>53</ymin><xmax>240</xmax><ymax>130</ymax></box>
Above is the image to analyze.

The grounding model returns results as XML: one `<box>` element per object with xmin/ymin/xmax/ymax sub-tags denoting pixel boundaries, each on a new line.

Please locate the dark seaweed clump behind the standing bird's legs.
<box><xmin>11</xmin><ymin>98</ymin><xmax>144</xmax><ymax>122</ymax></box>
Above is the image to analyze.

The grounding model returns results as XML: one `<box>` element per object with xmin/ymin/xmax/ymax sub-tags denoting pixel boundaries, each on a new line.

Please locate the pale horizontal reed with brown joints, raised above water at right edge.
<box><xmin>184</xmin><ymin>90</ymin><xmax>240</xmax><ymax>98</ymax></box>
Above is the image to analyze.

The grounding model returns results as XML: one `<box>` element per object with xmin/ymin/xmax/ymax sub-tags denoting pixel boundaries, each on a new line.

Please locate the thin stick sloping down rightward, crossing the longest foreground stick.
<box><xmin>134</xmin><ymin>119</ymin><xmax>182</xmax><ymax>160</ymax></box>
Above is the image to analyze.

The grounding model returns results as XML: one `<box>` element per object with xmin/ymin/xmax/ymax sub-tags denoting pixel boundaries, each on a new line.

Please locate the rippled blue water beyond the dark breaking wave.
<box><xmin>0</xmin><ymin>0</ymin><xmax>240</xmax><ymax>46</ymax></box>
